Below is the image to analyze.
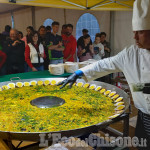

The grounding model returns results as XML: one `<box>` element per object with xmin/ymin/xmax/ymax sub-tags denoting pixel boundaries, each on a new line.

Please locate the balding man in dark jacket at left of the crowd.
<box><xmin>4</xmin><ymin>29</ymin><xmax>25</xmax><ymax>74</ymax></box>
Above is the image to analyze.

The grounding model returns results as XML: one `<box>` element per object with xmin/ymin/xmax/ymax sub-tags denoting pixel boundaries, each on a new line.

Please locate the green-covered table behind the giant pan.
<box><xmin>0</xmin><ymin>70</ymin><xmax>71</xmax><ymax>82</ymax></box>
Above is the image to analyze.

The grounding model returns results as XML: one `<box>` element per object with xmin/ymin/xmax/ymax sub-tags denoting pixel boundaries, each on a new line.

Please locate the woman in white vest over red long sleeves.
<box><xmin>25</xmin><ymin>31</ymin><xmax>46</xmax><ymax>71</ymax></box>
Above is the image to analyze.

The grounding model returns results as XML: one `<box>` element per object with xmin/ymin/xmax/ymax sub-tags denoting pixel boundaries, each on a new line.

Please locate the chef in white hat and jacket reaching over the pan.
<box><xmin>58</xmin><ymin>0</ymin><xmax>150</xmax><ymax>150</ymax></box>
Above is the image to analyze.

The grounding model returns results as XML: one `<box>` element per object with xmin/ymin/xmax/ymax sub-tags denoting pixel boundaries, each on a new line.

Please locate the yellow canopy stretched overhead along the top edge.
<box><xmin>0</xmin><ymin>0</ymin><xmax>134</xmax><ymax>10</ymax></box>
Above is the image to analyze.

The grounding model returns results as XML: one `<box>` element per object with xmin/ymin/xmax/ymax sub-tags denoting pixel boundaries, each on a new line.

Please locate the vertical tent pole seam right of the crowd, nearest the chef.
<box><xmin>109</xmin><ymin>11</ymin><xmax>115</xmax><ymax>56</ymax></box>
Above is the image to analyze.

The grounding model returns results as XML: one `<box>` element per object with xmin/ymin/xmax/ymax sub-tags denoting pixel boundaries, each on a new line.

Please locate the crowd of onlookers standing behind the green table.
<box><xmin>0</xmin><ymin>21</ymin><xmax>111</xmax><ymax>75</ymax></box>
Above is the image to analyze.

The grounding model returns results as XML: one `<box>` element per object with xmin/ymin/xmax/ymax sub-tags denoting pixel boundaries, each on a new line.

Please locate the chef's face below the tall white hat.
<box><xmin>134</xmin><ymin>30</ymin><xmax>150</xmax><ymax>50</ymax></box>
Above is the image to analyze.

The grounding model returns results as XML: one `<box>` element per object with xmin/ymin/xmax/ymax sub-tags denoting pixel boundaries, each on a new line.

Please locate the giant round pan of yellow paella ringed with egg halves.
<box><xmin>0</xmin><ymin>78</ymin><xmax>130</xmax><ymax>141</ymax></box>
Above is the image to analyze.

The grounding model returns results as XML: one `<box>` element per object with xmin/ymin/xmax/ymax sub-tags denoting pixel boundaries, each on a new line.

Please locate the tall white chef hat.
<box><xmin>132</xmin><ymin>0</ymin><xmax>150</xmax><ymax>31</ymax></box>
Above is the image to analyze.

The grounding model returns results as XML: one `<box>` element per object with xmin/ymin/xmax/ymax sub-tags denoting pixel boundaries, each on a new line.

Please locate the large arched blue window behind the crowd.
<box><xmin>76</xmin><ymin>13</ymin><xmax>100</xmax><ymax>42</ymax></box>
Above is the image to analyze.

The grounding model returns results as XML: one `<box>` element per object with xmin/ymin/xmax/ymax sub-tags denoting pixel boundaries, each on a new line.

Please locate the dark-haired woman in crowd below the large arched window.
<box><xmin>77</xmin><ymin>34</ymin><xmax>94</xmax><ymax>62</ymax></box>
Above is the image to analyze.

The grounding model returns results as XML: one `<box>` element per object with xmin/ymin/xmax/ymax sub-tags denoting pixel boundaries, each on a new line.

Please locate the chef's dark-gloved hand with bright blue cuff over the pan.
<box><xmin>57</xmin><ymin>70</ymin><xmax>83</xmax><ymax>89</ymax></box>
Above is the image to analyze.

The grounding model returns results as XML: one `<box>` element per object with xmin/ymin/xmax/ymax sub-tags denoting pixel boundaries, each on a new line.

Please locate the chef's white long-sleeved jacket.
<box><xmin>80</xmin><ymin>45</ymin><xmax>150</xmax><ymax>114</ymax></box>
